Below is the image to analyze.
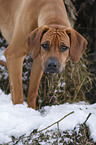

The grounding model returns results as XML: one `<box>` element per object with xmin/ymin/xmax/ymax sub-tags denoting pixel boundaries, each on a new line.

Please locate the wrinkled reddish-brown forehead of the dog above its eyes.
<box><xmin>42</xmin><ymin>28</ymin><xmax>69</xmax><ymax>44</ymax></box>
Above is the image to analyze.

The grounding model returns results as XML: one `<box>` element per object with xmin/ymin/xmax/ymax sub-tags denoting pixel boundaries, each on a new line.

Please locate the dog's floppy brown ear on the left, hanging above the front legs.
<box><xmin>26</xmin><ymin>25</ymin><xmax>49</xmax><ymax>59</ymax></box>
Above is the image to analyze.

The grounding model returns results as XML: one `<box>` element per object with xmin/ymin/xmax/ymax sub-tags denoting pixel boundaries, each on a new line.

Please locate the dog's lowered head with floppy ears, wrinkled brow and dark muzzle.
<box><xmin>27</xmin><ymin>25</ymin><xmax>87</xmax><ymax>73</ymax></box>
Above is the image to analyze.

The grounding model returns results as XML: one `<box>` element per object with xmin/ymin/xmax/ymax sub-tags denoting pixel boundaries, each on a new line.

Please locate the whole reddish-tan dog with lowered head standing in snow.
<box><xmin>0</xmin><ymin>0</ymin><xmax>87</xmax><ymax>109</ymax></box>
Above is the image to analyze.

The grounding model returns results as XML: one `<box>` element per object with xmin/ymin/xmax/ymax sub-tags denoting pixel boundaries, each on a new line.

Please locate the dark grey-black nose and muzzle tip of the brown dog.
<box><xmin>46</xmin><ymin>58</ymin><xmax>58</xmax><ymax>73</ymax></box>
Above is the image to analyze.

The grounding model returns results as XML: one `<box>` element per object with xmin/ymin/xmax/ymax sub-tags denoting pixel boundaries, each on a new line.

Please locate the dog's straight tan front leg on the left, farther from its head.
<box><xmin>6</xmin><ymin>56</ymin><xmax>24</xmax><ymax>104</ymax></box>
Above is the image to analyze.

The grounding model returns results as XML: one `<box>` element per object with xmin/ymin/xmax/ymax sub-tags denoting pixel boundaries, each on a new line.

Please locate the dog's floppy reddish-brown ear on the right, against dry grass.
<box><xmin>66</xmin><ymin>28</ymin><xmax>87</xmax><ymax>62</ymax></box>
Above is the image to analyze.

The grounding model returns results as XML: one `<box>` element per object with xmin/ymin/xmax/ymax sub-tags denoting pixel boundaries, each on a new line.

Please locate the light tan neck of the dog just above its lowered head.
<box><xmin>38</xmin><ymin>3</ymin><xmax>70</xmax><ymax>27</ymax></box>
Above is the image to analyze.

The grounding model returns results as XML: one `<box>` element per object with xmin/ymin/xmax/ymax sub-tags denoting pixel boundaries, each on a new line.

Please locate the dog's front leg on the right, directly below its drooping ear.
<box><xmin>27</xmin><ymin>57</ymin><xmax>43</xmax><ymax>109</ymax></box>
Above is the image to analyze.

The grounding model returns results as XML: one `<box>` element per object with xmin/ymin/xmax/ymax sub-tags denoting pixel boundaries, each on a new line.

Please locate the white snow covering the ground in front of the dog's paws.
<box><xmin>0</xmin><ymin>90</ymin><xmax>96</xmax><ymax>144</ymax></box>
